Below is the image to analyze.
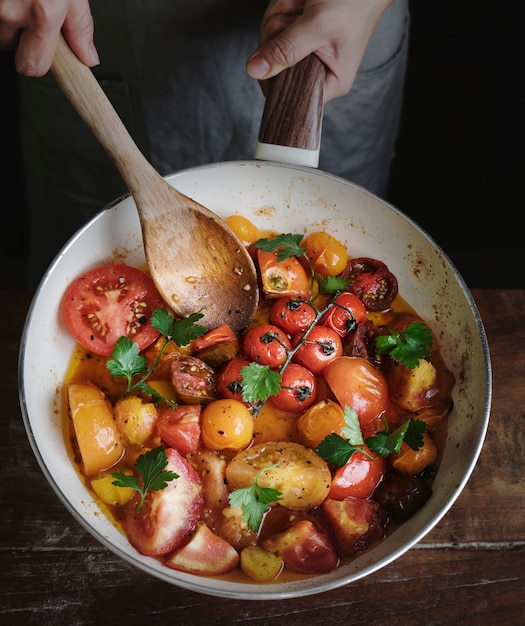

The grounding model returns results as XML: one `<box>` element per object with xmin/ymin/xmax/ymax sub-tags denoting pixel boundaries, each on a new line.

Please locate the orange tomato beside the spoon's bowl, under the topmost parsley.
<box><xmin>257</xmin><ymin>249</ymin><xmax>310</xmax><ymax>300</ymax></box>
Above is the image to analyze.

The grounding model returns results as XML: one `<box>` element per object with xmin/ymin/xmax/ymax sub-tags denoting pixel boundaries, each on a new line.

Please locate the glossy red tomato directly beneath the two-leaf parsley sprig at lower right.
<box><xmin>328</xmin><ymin>448</ymin><xmax>386</xmax><ymax>500</ymax></box>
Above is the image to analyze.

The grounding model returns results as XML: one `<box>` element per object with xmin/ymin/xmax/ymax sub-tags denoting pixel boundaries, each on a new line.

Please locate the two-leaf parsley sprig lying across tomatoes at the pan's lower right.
<box><xmin>316</xmin><ymin>405</ymin><xmax>427</xmax><ymax>467</ymax></box>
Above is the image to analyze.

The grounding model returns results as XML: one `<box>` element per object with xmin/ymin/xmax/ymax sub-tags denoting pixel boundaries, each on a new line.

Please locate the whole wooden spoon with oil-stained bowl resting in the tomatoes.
<box><xmin>51</xmin><ymin>36</ymin><xmax>259</xmax><ymax>332</ymax></box>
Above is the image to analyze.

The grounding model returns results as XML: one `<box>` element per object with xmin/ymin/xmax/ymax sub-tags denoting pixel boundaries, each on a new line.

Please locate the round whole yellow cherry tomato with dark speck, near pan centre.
<box><xmin>201</xmin><ymin>398</ymin><xmax>253</xmax><ymax>450</ymax></box>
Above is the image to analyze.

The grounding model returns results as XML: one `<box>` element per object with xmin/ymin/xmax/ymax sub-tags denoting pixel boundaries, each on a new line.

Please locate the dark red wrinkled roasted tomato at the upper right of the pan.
<box><xmin>341</xmin><ymin>257</ymin><xmax>398</xmax><ymax>311</ymax></box>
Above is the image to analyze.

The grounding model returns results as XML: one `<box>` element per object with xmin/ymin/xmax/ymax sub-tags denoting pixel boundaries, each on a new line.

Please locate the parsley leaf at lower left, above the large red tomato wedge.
<box><xmin>111</xmin><ymin>446</ymin><xmax>179</xmax><ymax>511</ymax></box>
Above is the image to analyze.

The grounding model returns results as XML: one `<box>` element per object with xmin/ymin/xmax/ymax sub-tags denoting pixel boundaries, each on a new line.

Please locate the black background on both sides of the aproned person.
<box><xmin>0</xmin><ymin>0</ymin><xmax>525</xmax><ymax>289</ymax></box>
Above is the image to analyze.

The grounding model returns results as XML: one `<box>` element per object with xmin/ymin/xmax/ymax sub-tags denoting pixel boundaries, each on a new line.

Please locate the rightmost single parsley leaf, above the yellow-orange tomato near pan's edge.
<box><xmin>376</xmin><ymin>322</ymin><xmax>432</xmax><ymax>369</ymax></box>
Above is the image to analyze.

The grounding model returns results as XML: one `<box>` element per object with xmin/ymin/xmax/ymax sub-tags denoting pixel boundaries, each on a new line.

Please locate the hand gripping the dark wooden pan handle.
<box><xmin>246</xmin><ymin>0</ymin><xmax>394</xmax><ymax>102</ymax></box>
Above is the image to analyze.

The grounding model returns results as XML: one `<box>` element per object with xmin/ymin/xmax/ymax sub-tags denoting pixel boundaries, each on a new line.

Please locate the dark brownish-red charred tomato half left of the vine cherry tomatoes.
<box><xmin>171</xmin><ymin>356</ymin><xmax>217</xmax><ymax>404</ymax></box>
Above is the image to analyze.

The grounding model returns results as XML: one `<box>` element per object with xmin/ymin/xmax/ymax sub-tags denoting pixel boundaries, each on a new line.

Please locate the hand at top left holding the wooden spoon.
<box><xmin>0</xmin><ymin>0</ymin><xmax>99</xmax><ymax>76</ymax></box>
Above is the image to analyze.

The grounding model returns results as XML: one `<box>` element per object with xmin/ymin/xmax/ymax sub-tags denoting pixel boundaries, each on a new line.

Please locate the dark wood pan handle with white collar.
<box><xmin>255</xmin><ymin>54</ymin><xmax>326</xmax><ymax>167</ymax></box>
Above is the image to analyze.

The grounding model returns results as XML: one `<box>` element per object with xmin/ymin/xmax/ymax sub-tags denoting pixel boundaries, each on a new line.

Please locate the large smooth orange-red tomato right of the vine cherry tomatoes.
<box><xmin>323</xmin><ymin>356</ymin><xmax>389</xmax><ymax>430</ymax></box>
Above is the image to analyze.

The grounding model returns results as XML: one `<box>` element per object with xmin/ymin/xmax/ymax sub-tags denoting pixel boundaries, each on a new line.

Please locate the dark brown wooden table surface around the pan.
<box><xmin>0</xmin><ymin>289</ymin><xmax>525</xmax><ymax>626</ymax></box>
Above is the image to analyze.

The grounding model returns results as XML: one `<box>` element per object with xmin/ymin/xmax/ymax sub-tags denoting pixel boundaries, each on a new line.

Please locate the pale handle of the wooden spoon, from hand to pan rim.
<box><xmin>51</xmin><ymin>35</ymin><xmax>160</xmax><ymax>195</ymax></box>
